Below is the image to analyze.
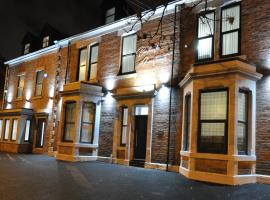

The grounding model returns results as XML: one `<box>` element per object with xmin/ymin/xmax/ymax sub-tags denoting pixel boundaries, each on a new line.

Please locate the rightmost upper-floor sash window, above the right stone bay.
<box><xmin>221</xmin><ymin>4</ymin><xmax>240</xmax><ymax>57</ymax></box>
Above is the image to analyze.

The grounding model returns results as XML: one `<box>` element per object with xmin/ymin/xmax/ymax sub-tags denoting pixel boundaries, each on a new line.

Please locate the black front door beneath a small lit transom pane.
<box><xmin>134</xmin><ymin>107</ymin><xmax>148</xmax><ymax>160</ymax></box>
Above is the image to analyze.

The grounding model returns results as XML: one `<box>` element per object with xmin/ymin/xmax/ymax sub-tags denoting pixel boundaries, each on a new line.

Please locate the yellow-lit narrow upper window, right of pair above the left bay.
<box><xmin>88</xmin><ymin>44</ymin><xmax>98</xmax><ymax>81</ymax></box>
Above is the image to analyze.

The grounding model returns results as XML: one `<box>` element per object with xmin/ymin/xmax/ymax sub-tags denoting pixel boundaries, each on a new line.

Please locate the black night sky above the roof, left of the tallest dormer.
<box><xmin>0</xmin><ymin>0</ymin><xmax>102</xmax><ymax>59</ymax></box>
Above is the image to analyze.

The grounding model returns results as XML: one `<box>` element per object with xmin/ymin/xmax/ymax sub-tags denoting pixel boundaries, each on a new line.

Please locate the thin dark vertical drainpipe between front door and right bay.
<box><xmin>166</xmin><ymin>5</ymin><xmax>179</xmax><ymax>171</ymax></box>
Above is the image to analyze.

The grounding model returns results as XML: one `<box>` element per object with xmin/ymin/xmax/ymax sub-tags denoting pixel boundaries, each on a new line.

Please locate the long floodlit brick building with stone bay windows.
<box><xmin>0</xmin><ymin>0</ymin><xmax>270</xmax><ymax>184</ymax></box>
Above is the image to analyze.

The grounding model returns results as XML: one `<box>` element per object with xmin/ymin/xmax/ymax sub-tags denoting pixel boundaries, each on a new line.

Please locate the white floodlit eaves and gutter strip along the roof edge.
<box><xmin>5</xmin><ymin>0</ymin><xmax>184</xmax><ymax>66</ymax></box>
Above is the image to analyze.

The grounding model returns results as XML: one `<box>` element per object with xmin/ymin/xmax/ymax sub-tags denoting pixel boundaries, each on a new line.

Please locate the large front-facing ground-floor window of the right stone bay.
<box><xmin>198</xmin><ymin>89</ymin><xmax>228</xmax><ymax>153</ymax></box>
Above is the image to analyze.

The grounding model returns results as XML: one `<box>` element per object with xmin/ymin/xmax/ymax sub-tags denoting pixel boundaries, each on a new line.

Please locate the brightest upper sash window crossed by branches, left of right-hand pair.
<box><xmin>196</xmin><ymin>11</ymin><xmax>215</xmax><ymax>61</ymax></box>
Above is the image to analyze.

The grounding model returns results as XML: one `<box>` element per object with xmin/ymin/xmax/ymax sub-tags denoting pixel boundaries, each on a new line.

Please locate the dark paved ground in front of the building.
<box><xmin>0</xmin><ymin>153</ymin><xmax>270</xmax><ymax>200</ymax></box>
